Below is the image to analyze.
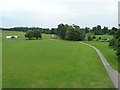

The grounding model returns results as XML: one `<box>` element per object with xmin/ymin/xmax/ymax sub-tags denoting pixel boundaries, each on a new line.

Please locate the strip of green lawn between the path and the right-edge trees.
<box><xmin>85</xmin><ymin>41</ymin><xmax>120</xmax><ymax>72</ymax></box>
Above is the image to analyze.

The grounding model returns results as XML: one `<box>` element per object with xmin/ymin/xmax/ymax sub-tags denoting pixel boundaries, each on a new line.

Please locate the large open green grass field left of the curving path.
<box><xmin>2</xmin><ymin>32</ymin><xmax>114</xmax><ymax>88</ymax></box>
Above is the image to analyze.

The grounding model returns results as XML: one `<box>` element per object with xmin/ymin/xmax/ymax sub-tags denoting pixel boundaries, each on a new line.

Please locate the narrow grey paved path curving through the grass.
<box><xmin>80</xmin><ymin>42</ymin><xmax>120</xmax><ymax>90</ymax></box>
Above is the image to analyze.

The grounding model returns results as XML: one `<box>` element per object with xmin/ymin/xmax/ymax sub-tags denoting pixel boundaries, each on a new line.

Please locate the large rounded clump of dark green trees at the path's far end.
<box><xmin>56</xmin><ymin>24</ymin><xmax>85</xmax><ymax>41</ymax></box>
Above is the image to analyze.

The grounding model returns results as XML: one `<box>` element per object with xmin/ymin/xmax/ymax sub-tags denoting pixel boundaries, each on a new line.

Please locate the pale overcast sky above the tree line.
<box><xmin>0</xmin><ymin>0</ymin><xmax>119</xmax><ymax>28</ymax></box>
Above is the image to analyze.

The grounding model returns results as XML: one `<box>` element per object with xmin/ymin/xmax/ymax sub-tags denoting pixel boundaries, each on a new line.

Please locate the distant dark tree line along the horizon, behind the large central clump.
<box><xmin>2</xmin><ymin>24</ymin><xmax>118</xmax><ymax>35</ymax></box>
